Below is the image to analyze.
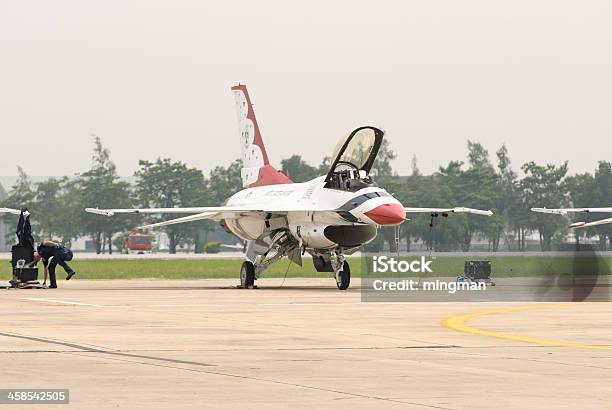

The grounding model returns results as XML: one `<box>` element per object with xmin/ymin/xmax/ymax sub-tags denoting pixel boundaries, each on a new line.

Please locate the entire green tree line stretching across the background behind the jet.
<box><xmin>0</xmin><ymin>137</ymin><xmax>612</xmax><ymax>253</ymax></box>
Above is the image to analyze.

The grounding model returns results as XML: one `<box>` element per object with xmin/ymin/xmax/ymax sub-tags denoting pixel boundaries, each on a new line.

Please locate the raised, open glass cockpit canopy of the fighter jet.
<box><xmin>325</xmin><ymin>127</ymin><xmax>384</xmax><ymax>191</ymax></box>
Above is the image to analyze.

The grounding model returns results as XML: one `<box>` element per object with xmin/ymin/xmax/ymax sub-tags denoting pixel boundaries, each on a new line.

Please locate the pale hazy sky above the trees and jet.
<box><xmin>0</xmin><ymin>0</ymin><xmax>612</xmax><ymax>175</ymax></box>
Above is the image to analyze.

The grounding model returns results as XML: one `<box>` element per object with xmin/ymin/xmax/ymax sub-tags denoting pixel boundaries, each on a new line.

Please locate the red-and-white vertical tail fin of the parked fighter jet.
<box><xmin>232</xmin><ymin>84</ymin><xmax>292</xmax><ymax>187</ymax></box>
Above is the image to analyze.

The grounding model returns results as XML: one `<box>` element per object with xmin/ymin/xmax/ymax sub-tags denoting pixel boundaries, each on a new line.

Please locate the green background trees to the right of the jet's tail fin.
<box><xmin>282</xmin><ymin>140</ymin><xmax>612</xmax><ymax>252</ymax></box>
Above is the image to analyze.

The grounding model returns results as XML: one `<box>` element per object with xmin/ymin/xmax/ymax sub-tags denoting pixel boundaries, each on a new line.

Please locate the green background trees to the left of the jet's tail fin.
<box><xmin>2</xmin><ymin>137</ymin><xmax>242</xmax><ymax>253</ymax></box>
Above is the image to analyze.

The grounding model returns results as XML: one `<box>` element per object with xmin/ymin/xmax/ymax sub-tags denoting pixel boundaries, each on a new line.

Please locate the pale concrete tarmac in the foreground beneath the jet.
<box><xmin>0</xmin><ymin>279</ymin><xmax>612</xmax><ymax>409</ymax></box>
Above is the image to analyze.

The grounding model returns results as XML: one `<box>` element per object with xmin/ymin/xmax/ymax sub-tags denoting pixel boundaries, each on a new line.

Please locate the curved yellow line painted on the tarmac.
<box><xmin>441</xmin><ymin>303</ymin><xmax>612</xmax><ymax>350</ymax></box>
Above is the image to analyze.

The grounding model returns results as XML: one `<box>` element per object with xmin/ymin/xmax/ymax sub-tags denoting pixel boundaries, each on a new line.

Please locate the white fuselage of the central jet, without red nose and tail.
<box><xmin>224</xmin><ymin>177</ymin><xmax>401</xmax><ymax>249</ymax></box>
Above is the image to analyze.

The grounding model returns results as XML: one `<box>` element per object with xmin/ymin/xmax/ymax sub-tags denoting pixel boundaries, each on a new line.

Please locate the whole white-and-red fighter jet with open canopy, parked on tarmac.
<box><xmin>86</xmin><ymin>84</ymin><xmax>492</xmax><ymax>290</ymax></box>
